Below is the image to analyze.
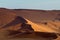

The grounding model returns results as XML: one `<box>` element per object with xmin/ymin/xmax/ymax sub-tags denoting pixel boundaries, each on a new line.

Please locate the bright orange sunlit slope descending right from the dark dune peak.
<box><xmin>26</xmin><ymin>19</ymin><xmax>56</xmax><ymax>32</ymax></box>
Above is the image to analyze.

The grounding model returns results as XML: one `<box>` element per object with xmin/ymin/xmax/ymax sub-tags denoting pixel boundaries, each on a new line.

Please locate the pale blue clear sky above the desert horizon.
<box><xmin>0</xmin><ymin>0</ymin><xmax>60</xmax><ymax>10</ymax></box>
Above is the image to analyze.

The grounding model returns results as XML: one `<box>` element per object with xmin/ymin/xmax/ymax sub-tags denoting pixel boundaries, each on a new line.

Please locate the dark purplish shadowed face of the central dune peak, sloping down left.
<box><xmin>2</xmin><ymin>16</ymin><xmax>27</xmax><ymax>28</ymax></box>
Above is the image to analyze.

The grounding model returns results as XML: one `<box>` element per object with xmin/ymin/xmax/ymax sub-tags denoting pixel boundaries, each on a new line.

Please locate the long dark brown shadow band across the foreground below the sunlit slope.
<box><xmin>8</xmin><ymin>31</ymin><xmax>58</xmax><ymax>39</ymax></box>
